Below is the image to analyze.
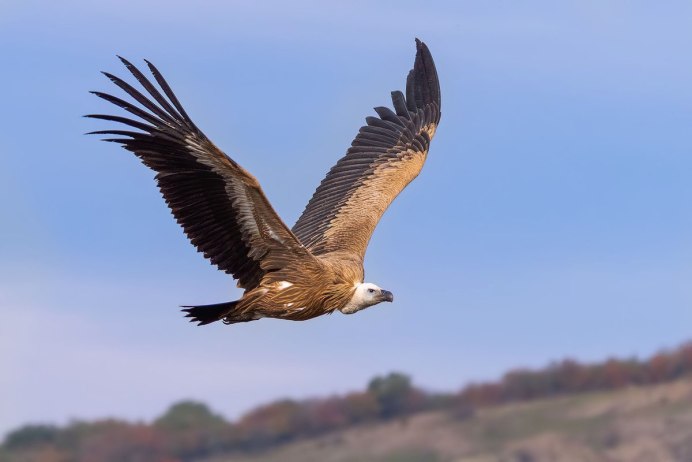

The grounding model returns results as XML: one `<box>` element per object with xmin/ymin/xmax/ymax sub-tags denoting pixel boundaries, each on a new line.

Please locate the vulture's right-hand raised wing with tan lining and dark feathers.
<box><xmin>293</xmin><ymin>39</ymin><xmax>440</xmax><ymax>259</ymax></box>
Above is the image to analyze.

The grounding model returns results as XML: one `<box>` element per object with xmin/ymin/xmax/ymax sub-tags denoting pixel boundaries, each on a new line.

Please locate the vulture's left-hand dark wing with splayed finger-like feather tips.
<box><xmin>86</xmin><ymin>58</ymin><xmax>313</xmax><ymax>289</ymax></box>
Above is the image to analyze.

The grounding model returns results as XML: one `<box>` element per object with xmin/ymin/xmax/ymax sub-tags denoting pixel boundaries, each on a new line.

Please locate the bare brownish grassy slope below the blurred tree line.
<box><xmin>205</xmin><ymin>378</ymin><xmax>692</xmax><ymax>462</ymax></box>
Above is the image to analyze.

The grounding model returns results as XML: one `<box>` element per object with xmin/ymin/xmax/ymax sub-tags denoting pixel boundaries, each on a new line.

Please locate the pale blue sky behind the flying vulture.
<box><xmin>0</xmin><ymin>0</ymin><xmax>692</xmax><ymax>433</ymax></box>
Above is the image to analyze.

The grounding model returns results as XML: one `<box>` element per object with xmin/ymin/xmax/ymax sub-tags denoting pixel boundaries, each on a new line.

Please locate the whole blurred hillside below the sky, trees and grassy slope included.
<box><xmin>0</xmin><ymin>343</ymin><xmax>692</xmax><ymax>462</ymax></box>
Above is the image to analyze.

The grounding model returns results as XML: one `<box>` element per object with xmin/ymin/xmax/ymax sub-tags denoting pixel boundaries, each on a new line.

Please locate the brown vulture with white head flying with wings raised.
<box><xmin>85</xmin><ymin>39</ymin><xmax>440</xmax><ymax>325</ymax></box>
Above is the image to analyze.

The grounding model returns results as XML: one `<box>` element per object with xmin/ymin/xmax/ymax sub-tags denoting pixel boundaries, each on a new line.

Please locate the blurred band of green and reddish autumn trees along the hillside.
<box><xmin>5</xmin><ymin>342</ymin><xmax>692</xmax><ymax>462</ymax></box>
